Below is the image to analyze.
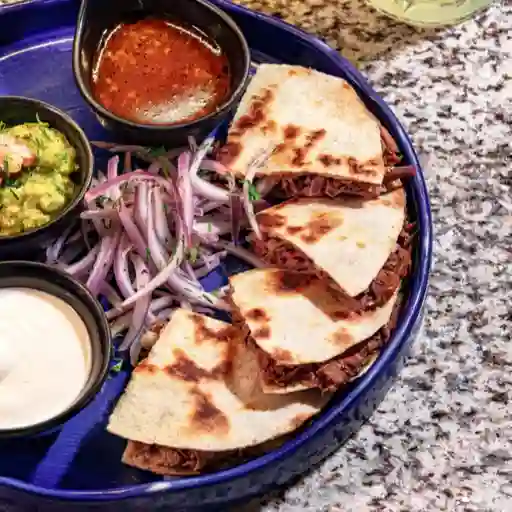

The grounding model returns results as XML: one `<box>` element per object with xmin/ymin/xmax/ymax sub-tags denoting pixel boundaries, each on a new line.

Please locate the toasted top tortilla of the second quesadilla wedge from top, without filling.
<box><xmin>256</xmin><ymin>188</ymin><xmax>405</xmax><ymax>297</ymax></box>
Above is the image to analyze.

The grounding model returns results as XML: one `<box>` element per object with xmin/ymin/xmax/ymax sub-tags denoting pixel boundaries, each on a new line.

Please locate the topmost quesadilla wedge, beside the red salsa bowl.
<box><xmin>218</xmin><ymin>64</ymin><xmax>387</xmax><ymax>198</ymax></box>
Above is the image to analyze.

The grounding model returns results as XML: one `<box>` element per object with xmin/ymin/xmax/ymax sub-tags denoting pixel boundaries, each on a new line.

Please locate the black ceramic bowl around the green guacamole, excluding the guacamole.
<box><xmin>0</xmin><ymin>96</ymin><xmax>94</xmax><ymax>260</ymax></box>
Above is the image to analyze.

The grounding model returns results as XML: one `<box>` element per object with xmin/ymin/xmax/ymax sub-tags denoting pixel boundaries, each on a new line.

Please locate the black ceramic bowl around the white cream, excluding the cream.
<box><xmin>0</xmin><ymin>261</ymin><xmax>112</xmax><ymax>440</ymax></box>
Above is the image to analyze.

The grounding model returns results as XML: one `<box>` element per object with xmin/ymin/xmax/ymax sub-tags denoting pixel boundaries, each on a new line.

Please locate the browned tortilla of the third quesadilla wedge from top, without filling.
<box><xmin>230</xmin><ymin>269</ymin><xmax>398</xmax><ymax>366</ymax></box>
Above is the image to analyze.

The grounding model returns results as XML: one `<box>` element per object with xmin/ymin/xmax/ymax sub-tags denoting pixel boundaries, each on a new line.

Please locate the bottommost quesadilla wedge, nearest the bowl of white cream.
<box><xmin>107</xmin><ymin>309</ymin><xmax>327</xmax><ymax>474</ymax></box>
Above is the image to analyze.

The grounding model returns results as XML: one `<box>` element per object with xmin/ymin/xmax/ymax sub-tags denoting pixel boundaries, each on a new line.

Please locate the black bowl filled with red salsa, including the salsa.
<box><xmin>73</xmin><ymin>0</ymin><xmax>250</xmax><ymax>146</ymax></box>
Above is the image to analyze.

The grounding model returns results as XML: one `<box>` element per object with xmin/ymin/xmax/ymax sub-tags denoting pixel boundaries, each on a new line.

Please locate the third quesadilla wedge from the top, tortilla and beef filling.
<box><xmin>229</xmin><ymin>269</ymin><xmax>398</xmax><ymax>393</ymax></box>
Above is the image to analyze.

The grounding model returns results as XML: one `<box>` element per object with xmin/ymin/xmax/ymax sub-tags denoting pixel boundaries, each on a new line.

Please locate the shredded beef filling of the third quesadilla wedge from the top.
<box><xmin>258</xmin><ymin>301</ymin><xmax>399</xmax><ymax>391</ymax></box>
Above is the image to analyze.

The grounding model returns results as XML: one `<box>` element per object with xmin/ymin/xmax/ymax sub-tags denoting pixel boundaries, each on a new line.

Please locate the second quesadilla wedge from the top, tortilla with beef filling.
<box><xmin>249</xmin><ymin>188</ymin><xmax>411</xmax><ymax>313</ymax></box>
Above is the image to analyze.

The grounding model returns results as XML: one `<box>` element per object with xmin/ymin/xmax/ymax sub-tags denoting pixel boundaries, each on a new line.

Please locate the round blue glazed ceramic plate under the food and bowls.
<box><xmin>0</xmin><ymin>0</ymin><xmax>432</xmax><ymax>512</ymax></box>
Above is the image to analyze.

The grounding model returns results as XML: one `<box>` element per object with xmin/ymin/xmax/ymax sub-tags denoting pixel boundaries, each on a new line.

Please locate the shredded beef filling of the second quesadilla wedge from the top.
<box><xmin>250</xmin><ymin>221</ymin><xmax>413</xmax><ymax>316</ymax></box>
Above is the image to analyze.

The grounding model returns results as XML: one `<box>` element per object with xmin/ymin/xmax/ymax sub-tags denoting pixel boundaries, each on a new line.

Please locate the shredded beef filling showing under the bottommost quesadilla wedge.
<box><xmin>124</xmin><ymin>441</ymin><xmax>216</xmax><ymax>475</ymax></box>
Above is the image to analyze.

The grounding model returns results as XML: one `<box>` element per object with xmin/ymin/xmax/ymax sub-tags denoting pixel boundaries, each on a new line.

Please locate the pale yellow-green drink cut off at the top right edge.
<box><xmin>368</xmin><ymin>0</ymin><xmax>493</xmax><ymax>26</ymax></box>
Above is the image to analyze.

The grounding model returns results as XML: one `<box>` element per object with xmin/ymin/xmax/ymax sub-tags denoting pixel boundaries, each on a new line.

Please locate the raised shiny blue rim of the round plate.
<box><xmin>0</xmin><ymin>0</ymin><xmax>433</xmax><ymax>502</ymax></box>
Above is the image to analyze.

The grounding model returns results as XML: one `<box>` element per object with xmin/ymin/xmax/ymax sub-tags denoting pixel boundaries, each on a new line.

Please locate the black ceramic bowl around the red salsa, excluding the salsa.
<box><xmin>73</xmin><ymin>0</ymin><xmax>250</xmax><ymax>146</ymax></box>
